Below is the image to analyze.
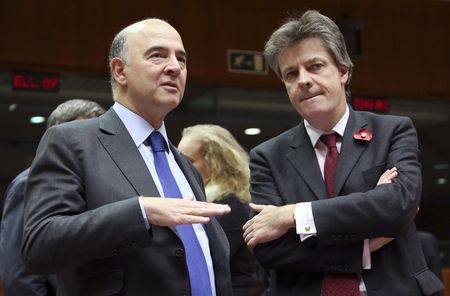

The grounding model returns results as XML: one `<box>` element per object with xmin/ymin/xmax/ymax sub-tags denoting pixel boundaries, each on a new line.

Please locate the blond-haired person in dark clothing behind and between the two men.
<box><xmin>178</xmin><ymin>124</ymin><xmax>264</xmax><ymax>296</ymax></box>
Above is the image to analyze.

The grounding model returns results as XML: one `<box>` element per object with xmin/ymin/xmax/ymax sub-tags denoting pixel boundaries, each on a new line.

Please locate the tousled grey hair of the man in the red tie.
<box><xmin>264</xmin><ymin>10</ymin><xmax>353</xmax><ymax>98</ymax></box>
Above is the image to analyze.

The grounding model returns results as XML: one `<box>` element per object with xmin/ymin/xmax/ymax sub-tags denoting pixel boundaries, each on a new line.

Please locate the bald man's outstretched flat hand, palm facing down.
<box><xmin>142</xmin><ymin>197</ymin><xmax>231</xmax><ymax>226</ymax></box>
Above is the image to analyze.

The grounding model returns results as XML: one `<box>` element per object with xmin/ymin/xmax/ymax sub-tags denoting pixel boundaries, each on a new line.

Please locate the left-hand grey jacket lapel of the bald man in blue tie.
<box><xmin>99</xmin><ymin>108</ymin><xmax>159</xmax><ymax>196</ymax></box>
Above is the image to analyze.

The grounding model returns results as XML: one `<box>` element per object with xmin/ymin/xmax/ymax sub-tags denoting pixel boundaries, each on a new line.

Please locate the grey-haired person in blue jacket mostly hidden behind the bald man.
<box><xmin>0</xmin><ymin>99</ymin><xmax>105</xmax><ymax>296</ymax></box>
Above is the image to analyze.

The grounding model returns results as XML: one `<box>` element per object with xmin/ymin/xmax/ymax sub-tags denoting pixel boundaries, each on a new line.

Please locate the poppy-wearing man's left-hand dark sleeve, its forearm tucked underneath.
<box><xmin>250</xmin><ymin>150</ymin><xmax>363</xmax><ymax>273</ymax></box>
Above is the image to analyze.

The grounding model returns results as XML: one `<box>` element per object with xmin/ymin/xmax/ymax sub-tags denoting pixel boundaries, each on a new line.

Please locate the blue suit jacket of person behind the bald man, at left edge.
<box><xmin>0</xmin><ymin>169</ymin><xmax>56</xmax><ymax>296</ymax></box>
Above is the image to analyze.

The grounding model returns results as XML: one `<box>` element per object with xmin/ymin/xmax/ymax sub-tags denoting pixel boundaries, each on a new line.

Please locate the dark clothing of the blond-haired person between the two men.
<box><xmin>216</xmin><ymin>194</ymin><xmax>265</xmax><ymax>296</ymax></box>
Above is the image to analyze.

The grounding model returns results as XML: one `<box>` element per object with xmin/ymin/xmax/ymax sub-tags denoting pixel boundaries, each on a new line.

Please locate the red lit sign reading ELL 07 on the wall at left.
<box><xmin>11</xmin><ymin>72</ymin><xmax>60</xmax><ymax>92</ymax></box>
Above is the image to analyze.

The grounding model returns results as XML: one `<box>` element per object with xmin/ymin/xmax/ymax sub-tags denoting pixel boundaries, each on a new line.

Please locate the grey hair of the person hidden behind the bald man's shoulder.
<box><xmin>47</xmin><ymin>99</ymin><xmax>105</xmax><ymax>128</ymax></box>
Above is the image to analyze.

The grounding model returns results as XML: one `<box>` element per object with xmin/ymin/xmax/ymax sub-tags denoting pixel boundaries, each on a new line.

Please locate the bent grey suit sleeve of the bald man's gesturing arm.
<box><xmin>22</xmin><ymin>125</ymin><xmax>150</xmax><ymax>272</ymax></box>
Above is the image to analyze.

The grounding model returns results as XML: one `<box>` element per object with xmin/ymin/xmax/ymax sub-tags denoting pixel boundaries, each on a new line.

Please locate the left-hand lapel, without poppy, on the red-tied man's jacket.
<box><xmin>286</xmin><ymin>122</ymin><xmax>327</xmax><ymax>199</ymax></box>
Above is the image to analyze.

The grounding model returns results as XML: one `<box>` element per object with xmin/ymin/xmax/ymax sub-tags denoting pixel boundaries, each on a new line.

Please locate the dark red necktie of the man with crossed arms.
<box><xmin>320</xmin><ymin>133</ymin><xmax>361</xmax><ymax>296</ymax></box>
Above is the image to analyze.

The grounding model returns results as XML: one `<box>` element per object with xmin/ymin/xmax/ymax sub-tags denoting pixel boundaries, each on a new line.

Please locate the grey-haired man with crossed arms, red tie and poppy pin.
<box><xmin>244</xmin><ymin>11</ymin><xmax>443</xmax><ymax>296</ymax></box>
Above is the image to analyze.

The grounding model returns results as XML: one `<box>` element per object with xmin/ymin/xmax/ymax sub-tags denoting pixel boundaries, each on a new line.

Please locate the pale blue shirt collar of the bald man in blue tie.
<box><xmin>113</xmin><ymin>102</ymin><xmax>170</xmax><ymax>151</ymax></box>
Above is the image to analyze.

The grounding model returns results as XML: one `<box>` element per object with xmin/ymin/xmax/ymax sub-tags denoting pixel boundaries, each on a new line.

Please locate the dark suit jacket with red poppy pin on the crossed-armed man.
<box><xmin>250</xmin><ymin>110</ymin><xmax>443</xmax><ymax>296</ymax></box>
